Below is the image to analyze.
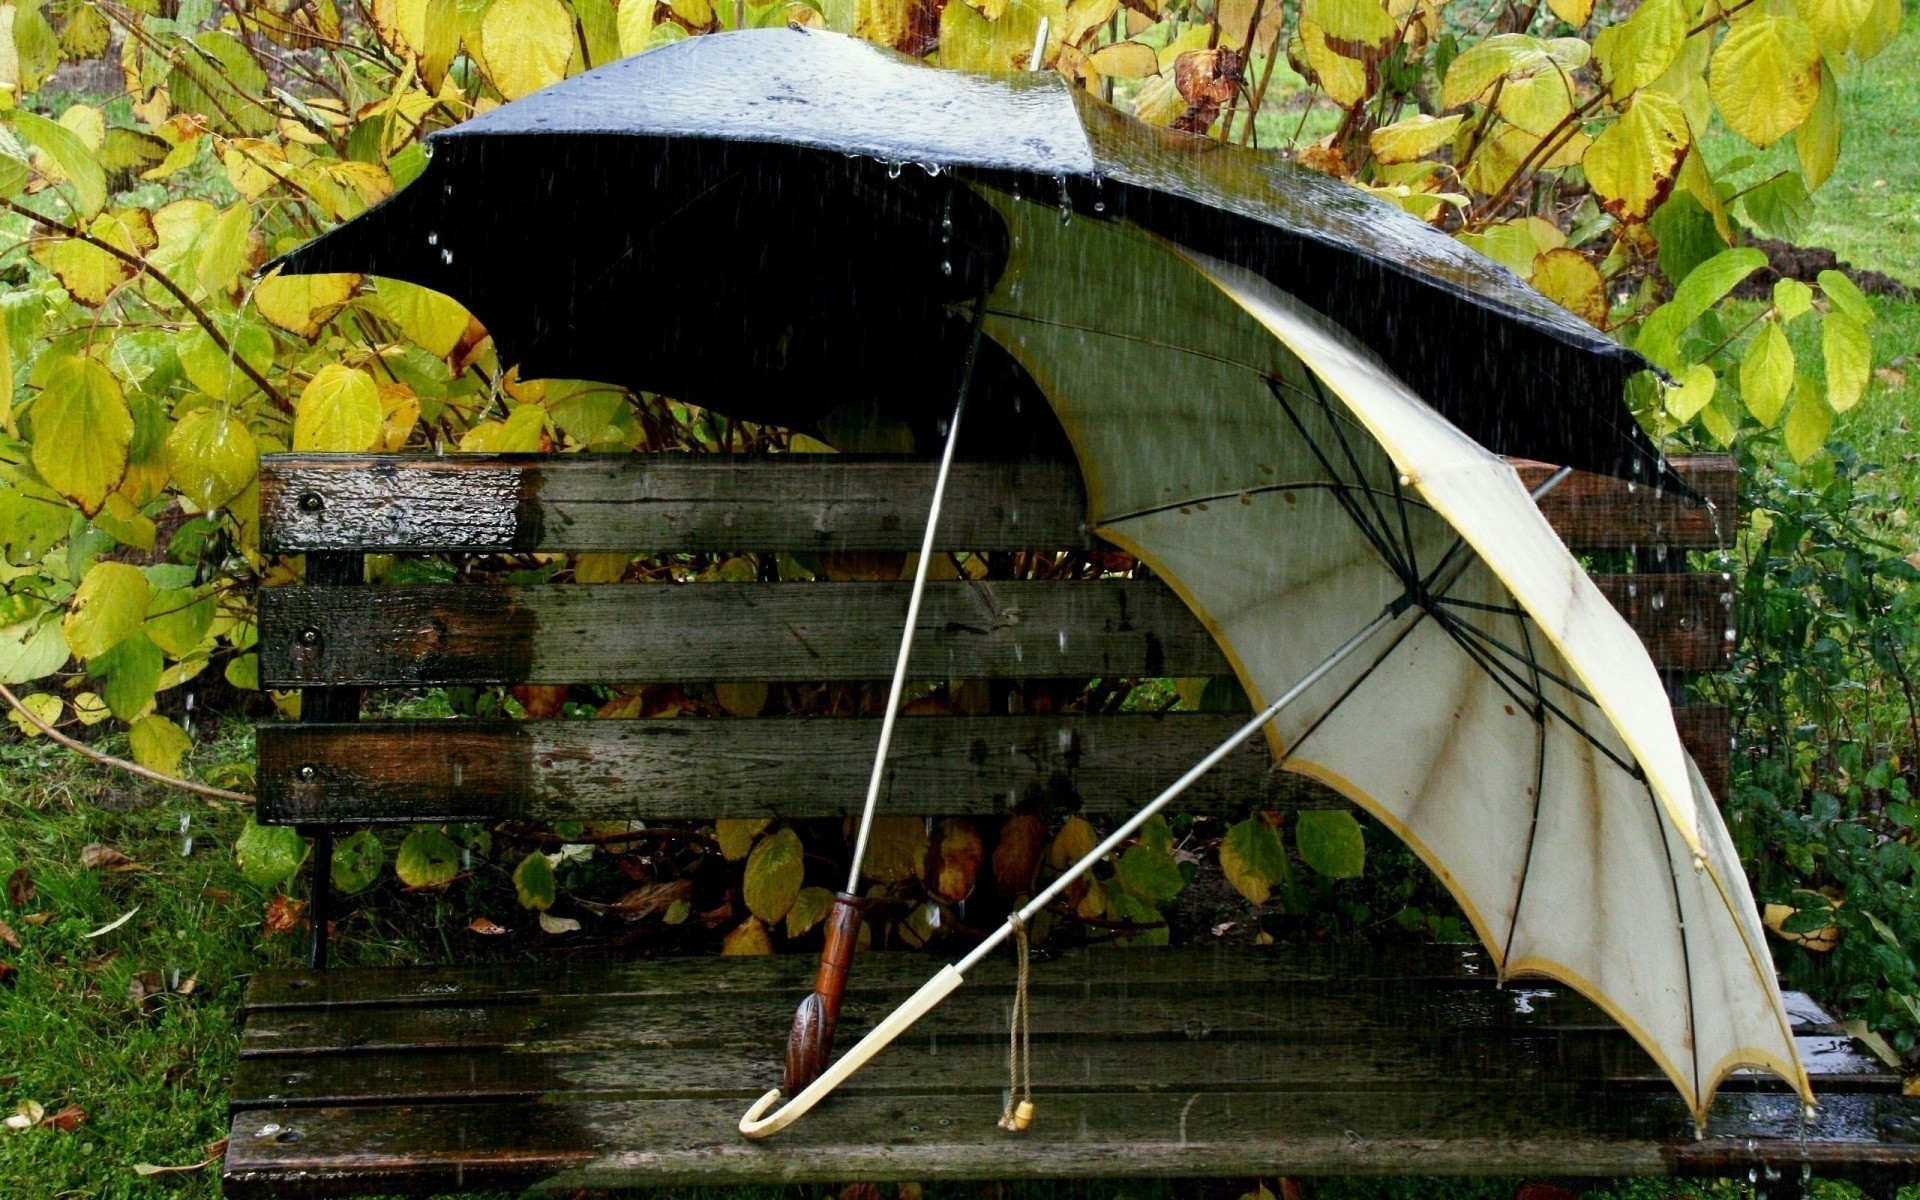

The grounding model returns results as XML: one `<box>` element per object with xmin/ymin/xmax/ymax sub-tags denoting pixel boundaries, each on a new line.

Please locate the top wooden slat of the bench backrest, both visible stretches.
<box><xmin>259</xmin><ymin>455</ymin><xmax>1736</xmax><ymax>553</ymax></box>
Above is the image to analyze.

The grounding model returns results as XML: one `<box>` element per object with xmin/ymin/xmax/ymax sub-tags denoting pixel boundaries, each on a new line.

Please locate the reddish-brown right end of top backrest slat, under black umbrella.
<box><xmin>1515</xmin><ymin>455</ymin><xmax>1740</xmax><ymax>551</ymax></box>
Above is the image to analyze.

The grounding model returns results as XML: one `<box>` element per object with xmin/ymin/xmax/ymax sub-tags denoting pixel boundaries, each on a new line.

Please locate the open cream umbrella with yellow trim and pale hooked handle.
<box><xmin>741</xmin><ymin>192</ymin><xmax>1812</xmax><ymax>1137</ymax></box>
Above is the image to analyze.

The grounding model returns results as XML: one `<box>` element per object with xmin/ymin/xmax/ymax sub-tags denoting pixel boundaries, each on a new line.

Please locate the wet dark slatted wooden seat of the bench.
<box><xmin>227</xmin><ymin>947</ymin><xmax>1920</xmax><ymax>1196</ymax></box>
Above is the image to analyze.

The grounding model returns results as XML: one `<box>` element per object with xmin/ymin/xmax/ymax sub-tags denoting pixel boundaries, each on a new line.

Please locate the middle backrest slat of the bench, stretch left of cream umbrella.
<box><xmin>259</xmin><ymin>580</ymin><xmax>1229</xmax><ymax>687</ymax></box>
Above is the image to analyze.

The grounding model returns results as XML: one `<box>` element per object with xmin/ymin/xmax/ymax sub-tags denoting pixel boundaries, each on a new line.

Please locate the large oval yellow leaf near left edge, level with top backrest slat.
<box><xmin>33</xmin><ymin>357</ymin><xmax>132</xmax><ymax>516</ymax></box>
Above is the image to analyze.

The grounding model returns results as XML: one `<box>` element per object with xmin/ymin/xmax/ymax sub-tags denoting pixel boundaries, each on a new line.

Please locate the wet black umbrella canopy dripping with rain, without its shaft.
<box><xmin>278</xmin><ymin>29</ymin><xmax>1684</xmax><ymax>490</ymax></box>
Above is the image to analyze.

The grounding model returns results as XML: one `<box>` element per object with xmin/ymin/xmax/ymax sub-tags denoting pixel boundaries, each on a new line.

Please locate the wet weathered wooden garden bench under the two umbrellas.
<box><xmin>225</xmin><ymin>455</ymin><xmax>1920</xmax><ymax>1196</ymax></box>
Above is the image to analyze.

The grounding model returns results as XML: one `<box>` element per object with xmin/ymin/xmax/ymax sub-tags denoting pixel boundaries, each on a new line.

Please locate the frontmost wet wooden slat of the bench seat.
<box><xmin>214</xmin><ymin>1090</ymin><xmax>1920</xmax><ymax>1198</ymax></box>
